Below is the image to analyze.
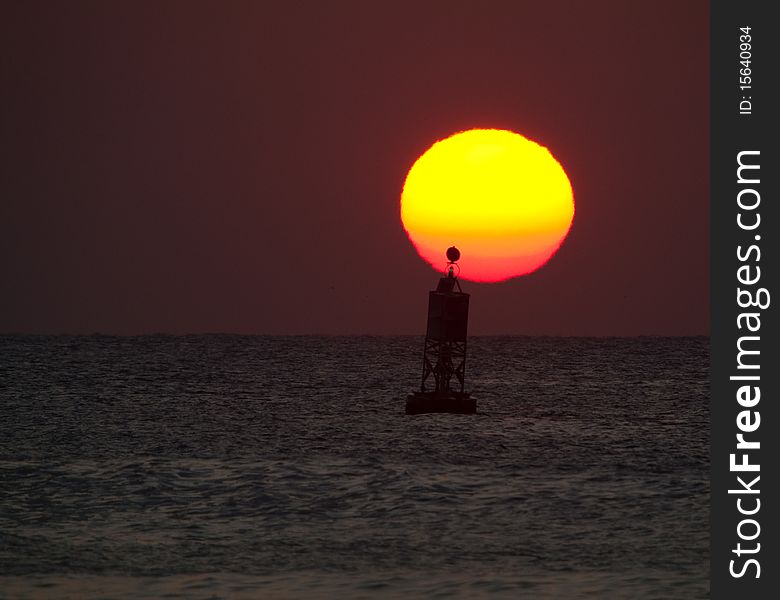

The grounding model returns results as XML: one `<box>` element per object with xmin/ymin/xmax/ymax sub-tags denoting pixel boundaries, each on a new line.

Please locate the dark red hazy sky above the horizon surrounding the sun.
<box><xmin>0</xmin><ymin>0</ymin><xmax>709</xmax><ymax>335</ymax></box>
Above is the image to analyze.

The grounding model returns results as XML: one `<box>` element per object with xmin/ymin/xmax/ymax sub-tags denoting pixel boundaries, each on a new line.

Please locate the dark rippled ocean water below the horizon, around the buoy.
<box><xmin>0</xmin><ymin>336</ymin><xmax>709</xmax><ymax>600</ymax></box>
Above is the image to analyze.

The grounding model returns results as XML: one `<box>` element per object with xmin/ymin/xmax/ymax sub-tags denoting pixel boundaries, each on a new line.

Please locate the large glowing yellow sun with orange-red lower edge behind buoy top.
<box><xmin>401</xmin><ymin>129</ymin><xmax>574</xmax><ymax>282</ymax></box>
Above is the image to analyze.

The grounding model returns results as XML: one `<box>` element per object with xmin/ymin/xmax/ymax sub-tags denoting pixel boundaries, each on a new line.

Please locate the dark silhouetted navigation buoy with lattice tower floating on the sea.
<box><xmin>406</xmin><ymin>246</ymin><xmax>477</xmax><ymax>415</ymax></box>
